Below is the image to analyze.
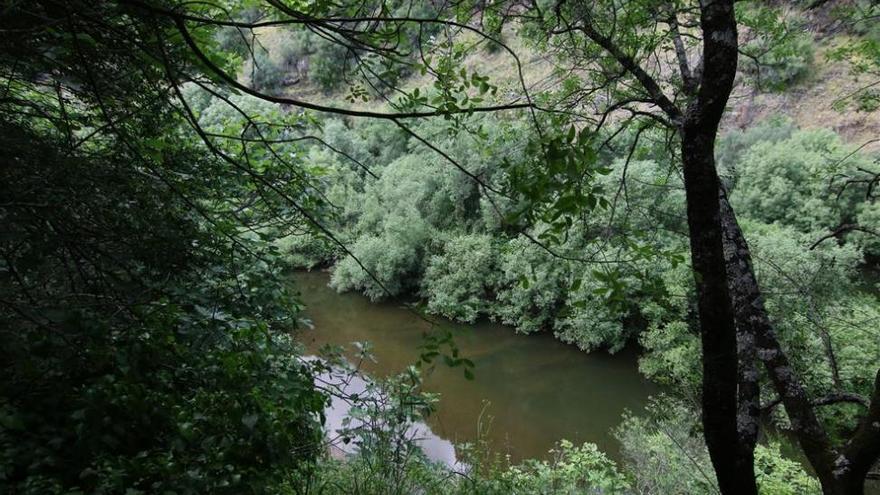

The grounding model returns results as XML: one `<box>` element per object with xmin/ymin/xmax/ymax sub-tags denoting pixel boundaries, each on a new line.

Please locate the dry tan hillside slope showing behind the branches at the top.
<box><xmin>251</xmin><ymin>7</ymin><xmax>880</xmax><ymax>152</ymax></box>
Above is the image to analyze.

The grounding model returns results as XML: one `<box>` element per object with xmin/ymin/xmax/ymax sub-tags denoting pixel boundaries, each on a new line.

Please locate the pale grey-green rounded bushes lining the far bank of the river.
<box><xmin>294</xmin><ymin>118</ymin><xmax>877</xmax><ymax>369</ymax></box>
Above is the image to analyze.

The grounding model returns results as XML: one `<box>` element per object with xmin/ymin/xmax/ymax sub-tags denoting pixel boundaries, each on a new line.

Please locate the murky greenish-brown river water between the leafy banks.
<box><xmin>294</xmin><ymin>272</ymin><xmax>657</xmax><ymax>462</ymax></box>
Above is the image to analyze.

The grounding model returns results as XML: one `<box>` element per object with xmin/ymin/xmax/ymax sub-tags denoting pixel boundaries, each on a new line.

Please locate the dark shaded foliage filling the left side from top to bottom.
<box><xmin>0</xmin><ymin>2</ymin><xmax>336</xmax><ymax>494</ymax></box>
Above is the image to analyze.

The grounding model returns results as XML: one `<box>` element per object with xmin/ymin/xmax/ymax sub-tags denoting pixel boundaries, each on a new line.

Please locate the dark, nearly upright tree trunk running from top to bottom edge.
<box><xmin>680</xmin><ymin>0</ymin><xmax>758</xmax><ymax>495</ymax></box>
